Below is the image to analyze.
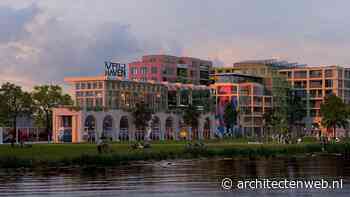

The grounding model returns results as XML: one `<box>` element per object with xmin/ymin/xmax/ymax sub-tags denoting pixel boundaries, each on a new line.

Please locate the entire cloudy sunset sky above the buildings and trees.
<box><xmin>0</xmin><ymin>0</ymin><xmax>350</xmax><ymax>88</ymax></box>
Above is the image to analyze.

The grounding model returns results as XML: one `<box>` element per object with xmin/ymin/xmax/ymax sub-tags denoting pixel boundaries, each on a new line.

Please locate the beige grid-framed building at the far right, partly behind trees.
<box><xmin>279</xmin><ymin>65</ymin><xmax>350</xmax><ymax>134</ymax></box>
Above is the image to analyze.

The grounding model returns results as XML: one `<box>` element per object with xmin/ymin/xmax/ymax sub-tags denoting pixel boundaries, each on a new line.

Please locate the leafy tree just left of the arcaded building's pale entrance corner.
<box><xmin>32</xmin><ymin>85</ymin><xmax>73</xmax><ymax>140</ymax></box>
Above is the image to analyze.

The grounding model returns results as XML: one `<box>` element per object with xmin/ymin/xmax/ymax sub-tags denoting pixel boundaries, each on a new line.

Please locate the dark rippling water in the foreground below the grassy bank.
<box><xmin>0</xmin><ymin>156</ymin><xmax>350</xmax><ymax>197</ymax></box>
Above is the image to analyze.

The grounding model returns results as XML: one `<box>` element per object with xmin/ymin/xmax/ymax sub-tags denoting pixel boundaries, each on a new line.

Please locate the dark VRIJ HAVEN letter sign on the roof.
<box><xmin>105</xmin><ymin>62</ymin><xmax>128</xmax><ymax>80</ymax></box>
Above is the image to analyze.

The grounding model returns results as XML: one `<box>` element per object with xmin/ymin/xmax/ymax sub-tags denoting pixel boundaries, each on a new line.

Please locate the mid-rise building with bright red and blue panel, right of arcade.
<box><xmin>211</xmin><ymin>82</ymin><xmax>272</xmax><ymax>136</ymax></box>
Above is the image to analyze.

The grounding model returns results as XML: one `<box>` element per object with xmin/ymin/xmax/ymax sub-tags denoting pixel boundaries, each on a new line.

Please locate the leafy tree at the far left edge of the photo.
<box><xmin>0</xmin><ymin>82</ymin><xmax>33</xmax><ymax>143</ymax></box>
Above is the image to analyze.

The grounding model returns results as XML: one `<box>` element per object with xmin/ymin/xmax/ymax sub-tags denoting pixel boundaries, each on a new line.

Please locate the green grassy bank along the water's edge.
<box><xmin>0</xmin><ymin>141</ymin><xmax>350</xmax><ymax>168</ymax></box>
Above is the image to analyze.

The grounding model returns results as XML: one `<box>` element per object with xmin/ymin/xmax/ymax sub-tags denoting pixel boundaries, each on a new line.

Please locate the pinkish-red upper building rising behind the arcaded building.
<box><xmin>128</xmin><ymin>55</ymin><xmax>212</xmax><ymax>85</ymax></box>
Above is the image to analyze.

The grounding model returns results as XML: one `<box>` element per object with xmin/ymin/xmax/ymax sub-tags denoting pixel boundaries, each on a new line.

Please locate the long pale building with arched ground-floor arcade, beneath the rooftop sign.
<box><xmin>53</xmin><ymin>76</ymin><xmax>214</xmax><ymax>143</ymax></box>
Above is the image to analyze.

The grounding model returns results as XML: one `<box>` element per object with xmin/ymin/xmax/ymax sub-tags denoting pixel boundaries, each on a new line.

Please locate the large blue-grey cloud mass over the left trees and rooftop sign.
<box><xmin>0</xmin><ymin>2</ymin><xmax>183</xmax><ymax>86</ymax></box>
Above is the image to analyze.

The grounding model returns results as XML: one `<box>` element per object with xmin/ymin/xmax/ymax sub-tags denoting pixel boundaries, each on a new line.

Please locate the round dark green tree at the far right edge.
<box><xmin>320</xmin><ymin>95</ymin><xmax>349</xmax><ymax>138</ymax></box>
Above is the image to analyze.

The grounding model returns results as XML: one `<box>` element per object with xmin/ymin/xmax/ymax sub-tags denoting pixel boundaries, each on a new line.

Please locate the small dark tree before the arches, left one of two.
<box><xmin>132</xmin><ymin>102</ymin><xmax>153</xmax><ymax>130</ymax></box>
